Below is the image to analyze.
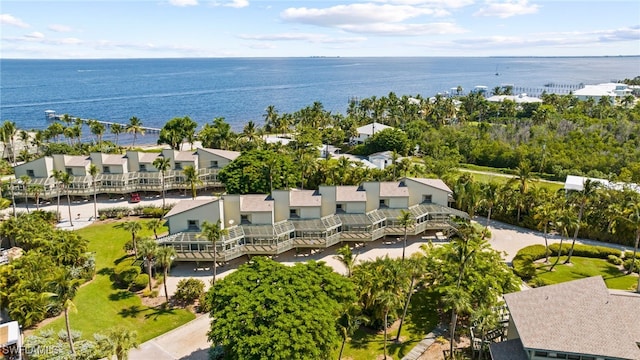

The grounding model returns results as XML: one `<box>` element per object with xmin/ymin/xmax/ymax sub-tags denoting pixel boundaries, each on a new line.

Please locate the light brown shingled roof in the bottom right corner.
<box><xmin>504</xmin><ymin>276</ymin><xmax>640</xmax><ymax>359</ymax></box>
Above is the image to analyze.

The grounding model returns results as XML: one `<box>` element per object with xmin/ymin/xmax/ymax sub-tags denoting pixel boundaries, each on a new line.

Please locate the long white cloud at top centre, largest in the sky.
<box><xmin>280</xmin><ymin>3</ymin><xmax>436</xmax><ymax>27</ymax></box>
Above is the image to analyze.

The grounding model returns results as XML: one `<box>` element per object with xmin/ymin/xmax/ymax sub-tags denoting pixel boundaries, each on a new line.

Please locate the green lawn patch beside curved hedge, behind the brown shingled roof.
<box><xmin>537</xmin><ymin>256</ymin><xmax>638</xmax><ymax>290</ymax></box>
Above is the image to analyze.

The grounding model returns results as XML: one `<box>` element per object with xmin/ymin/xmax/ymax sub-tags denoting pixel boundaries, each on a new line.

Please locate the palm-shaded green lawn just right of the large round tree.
<box><xmin>334</xmin><ymin>289</ymin><xmax>438</xmax><ymax>359</ymax></box>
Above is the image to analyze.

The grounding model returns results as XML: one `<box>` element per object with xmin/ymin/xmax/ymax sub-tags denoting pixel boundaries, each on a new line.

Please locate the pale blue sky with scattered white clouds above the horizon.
<box><xmin>0</xmin><ymin>0</ymin><xmax>640</xmax><ymax>59</ymax></box>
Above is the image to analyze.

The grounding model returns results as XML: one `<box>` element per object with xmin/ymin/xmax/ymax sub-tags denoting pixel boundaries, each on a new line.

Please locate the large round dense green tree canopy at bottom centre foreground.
<box><xmin>207</xmin><ymin>257</ymin><xmax>355</xmax><ymax>360</ymax></box>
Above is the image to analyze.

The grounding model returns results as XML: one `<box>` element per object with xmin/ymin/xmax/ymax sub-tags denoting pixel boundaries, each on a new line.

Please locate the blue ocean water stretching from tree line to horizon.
<box><xmin>0</xmin><ymin>57</ymin><xmax>640</xmax><ymax>130</ymax></box>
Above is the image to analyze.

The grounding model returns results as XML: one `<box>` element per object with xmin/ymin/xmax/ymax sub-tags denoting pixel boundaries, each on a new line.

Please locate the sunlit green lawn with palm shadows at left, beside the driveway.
<box><xmin>38</xmin><ymin>219</ymin><xmax>195</xmax><ymax>342</ymax></box>
